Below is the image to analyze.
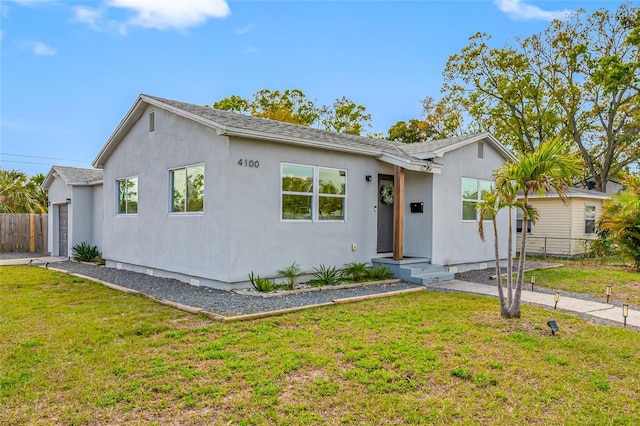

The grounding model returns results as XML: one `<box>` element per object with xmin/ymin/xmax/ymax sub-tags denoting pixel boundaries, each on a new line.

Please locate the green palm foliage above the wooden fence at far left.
<box><xmin>0</xmin><ymin>169</ymin><xmax>47</xmax><ymax>213</ymax></box>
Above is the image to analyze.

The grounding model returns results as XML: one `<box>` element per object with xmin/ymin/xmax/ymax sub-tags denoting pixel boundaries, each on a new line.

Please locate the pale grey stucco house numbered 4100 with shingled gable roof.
<box><xmin>47</xmin><ymin>95</ymin><xmax>514</xmax><ymax>289</ymax></box>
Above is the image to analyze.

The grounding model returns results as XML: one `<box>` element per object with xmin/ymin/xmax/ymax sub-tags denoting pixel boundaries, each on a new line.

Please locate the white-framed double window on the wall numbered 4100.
<box><xmin>281</xmin><ymin>164</ymin><xmax>347</xmax><ymax>222</ymax></box>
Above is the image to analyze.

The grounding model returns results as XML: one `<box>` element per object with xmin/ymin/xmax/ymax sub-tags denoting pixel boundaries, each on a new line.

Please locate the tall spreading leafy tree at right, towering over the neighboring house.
<box><xmin>442</xmin><ymin>3</ymin><xmax>640</xmax><ymax>191</ymax></box>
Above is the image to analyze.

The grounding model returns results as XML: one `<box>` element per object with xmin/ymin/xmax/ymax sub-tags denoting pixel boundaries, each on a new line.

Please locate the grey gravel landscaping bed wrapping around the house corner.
<box><xmin>49</xmin><ymin>262</ymin><xmax>421</xmax><ymax>316</ymax></box>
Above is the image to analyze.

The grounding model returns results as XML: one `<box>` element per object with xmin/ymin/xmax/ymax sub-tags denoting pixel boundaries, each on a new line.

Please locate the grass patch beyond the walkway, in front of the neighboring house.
<box><xmin>525</xmin><ymin>259</ymin><xmax>640</xmax><ymax>306</ymax></box>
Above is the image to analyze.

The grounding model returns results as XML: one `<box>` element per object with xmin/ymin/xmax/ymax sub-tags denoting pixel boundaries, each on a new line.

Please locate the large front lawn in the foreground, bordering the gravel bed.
<box><xmin>0</xmin><ymin>266</ymin><xmax>640</xmax><ymax>425</ymax></box>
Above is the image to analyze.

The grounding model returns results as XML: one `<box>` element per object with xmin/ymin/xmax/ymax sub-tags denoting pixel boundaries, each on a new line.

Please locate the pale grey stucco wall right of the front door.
<box><xmin>432</xmin><ymin>143</ymin><xmax>508</xmax><ymax>272</ymax></box>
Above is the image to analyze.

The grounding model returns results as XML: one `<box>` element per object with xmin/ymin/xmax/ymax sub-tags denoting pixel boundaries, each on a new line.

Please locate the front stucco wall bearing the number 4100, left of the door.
<box><xmin>226</xmin><ymin>138</ymin><xmax>393</xmax><ymax>282</ymax></box>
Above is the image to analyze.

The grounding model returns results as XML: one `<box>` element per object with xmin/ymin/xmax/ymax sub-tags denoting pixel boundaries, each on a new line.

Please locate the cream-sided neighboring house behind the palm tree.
<box><xmin>516</xmin><ymin>188</ymin><xmax>610</xmax><ymax>256</ymax></box>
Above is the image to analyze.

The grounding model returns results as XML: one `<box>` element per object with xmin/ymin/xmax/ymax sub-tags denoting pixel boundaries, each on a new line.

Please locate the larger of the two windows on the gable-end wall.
<box><xmin>169</xmin><ymin>164</ymin><xmax>204</xmax><ymax>213</ymax></box>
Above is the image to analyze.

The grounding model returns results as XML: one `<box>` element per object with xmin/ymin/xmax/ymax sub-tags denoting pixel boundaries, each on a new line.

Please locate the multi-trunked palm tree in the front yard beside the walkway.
<box><xmin>477</xmin><ymin>138</ymin><xmax>581</xmax><ymax>318</ymax></box>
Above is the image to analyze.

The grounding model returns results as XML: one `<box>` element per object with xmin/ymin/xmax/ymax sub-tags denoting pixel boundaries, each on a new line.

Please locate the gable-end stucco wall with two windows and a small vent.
<box><xmin>103</xmin><ymin>108</ymin><xmax>229</xmax><ymax>282</ymax></box>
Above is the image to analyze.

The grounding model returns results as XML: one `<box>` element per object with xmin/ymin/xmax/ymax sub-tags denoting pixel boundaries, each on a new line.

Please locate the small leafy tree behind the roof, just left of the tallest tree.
<box><xmin>387</xmin><ymin>97</ymin><xmax>462</xmax><ymax>143</ymax></box>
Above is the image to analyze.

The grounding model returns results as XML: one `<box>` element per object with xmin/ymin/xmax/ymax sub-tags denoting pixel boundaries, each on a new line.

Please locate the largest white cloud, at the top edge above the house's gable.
<box><xmin>107</xmin><ymin>0</ymin><xmax>231</xmax><ymax>30</ymax></box>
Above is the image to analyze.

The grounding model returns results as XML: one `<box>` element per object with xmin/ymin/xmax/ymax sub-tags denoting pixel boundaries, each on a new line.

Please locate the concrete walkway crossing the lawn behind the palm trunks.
<box><xmin>429</xmin><ymin>280</ymin><xmax>640</xmax><ymax>328</ymax></box>
